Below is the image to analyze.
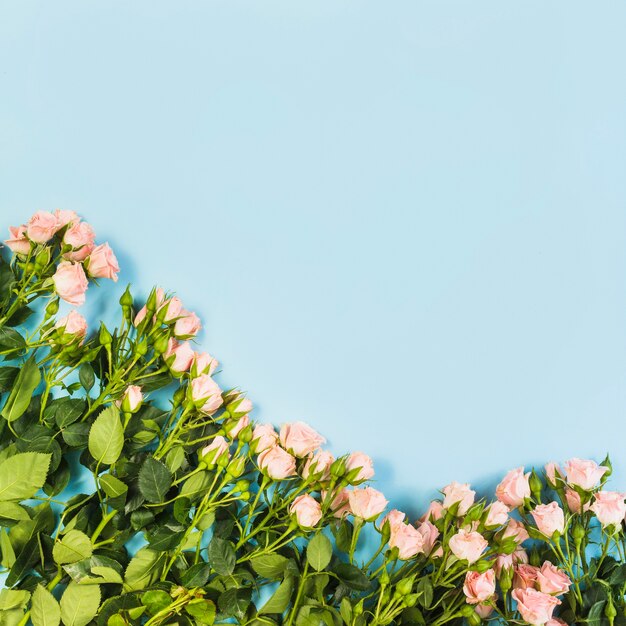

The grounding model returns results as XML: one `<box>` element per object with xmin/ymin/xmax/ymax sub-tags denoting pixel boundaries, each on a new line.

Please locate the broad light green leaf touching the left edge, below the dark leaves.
<box><xmin>0</xmin><ymin>452</ymin><xmax>51</xmax><ymax>502</ymax></box>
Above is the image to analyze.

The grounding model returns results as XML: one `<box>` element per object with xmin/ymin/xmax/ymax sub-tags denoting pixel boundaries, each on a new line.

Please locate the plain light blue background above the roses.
<box><xmin>0</xmin><ymin>0</ymin><xmax>626</xmax><ymax>513</ymax></box>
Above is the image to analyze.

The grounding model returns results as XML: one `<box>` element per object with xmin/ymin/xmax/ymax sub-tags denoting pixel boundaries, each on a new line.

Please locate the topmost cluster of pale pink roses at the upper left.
<box><xmin>5</xmin><ymin>209</ymin><xmax>120</xmax><ymax>306</ymax></box>
